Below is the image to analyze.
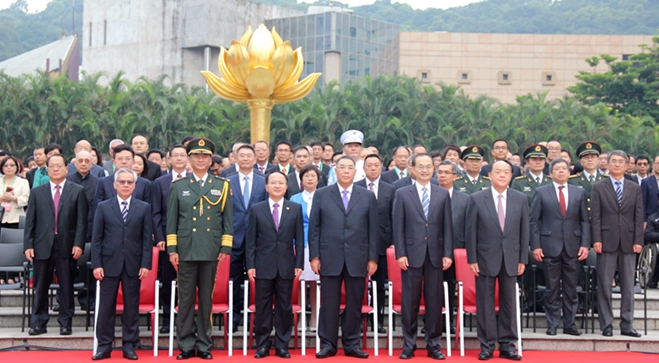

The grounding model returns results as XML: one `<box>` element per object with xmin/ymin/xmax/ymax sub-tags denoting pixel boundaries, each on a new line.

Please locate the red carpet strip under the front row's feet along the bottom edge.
<box><xmin>0</xmin><ymin>349</ymin><xmax>659</xmax><ymax>363</ymax></box>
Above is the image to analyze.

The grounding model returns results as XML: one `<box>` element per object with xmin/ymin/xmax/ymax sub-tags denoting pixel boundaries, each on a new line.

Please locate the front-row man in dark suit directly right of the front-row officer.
<box><xmin>245</xmin><ymin>171</ymin><xmax>304</xmax><ymax>358</ymax></box>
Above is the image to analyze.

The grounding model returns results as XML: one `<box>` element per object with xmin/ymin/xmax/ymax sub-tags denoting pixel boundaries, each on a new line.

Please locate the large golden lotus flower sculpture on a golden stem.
<box><xmin>201</xmin><ymin>24</ymin><xmax>321</xmax><ymax>144</ymax></box>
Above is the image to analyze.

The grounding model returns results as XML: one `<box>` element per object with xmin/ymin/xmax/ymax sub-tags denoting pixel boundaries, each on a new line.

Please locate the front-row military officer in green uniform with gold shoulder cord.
<box><xmin>167</xmin><ymin>138</ymin><xmax>233</xmax><ymax>360</ymax></box>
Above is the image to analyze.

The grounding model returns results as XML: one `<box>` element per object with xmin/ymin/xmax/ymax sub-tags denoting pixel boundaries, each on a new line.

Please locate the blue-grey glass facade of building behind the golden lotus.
<box><xmin>265</xmin><ymin>12</ymin><xmax>400</xmax><ymax>84</ymax></box>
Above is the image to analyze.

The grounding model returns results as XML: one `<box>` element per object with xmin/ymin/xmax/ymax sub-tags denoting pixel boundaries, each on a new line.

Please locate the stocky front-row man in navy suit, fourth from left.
<box><xmin>309</xmin><ymin>156</ymin><xmax>380</xmax><ymax>358</ymax></box>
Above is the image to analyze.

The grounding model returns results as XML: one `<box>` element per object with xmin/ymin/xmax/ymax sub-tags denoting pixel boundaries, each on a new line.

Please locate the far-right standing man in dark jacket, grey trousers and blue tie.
<box><xmin>591</xmin><ymin>150</ymin><xmax>645</xmax><ymax>337</ymax></box>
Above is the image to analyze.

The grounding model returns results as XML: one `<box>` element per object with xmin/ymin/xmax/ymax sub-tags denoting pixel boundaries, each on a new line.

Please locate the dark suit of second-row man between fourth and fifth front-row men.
<box><xmin>355</xmin><ymin>178</ymin><xmax>396</xmax><ymax>331</ymax></box>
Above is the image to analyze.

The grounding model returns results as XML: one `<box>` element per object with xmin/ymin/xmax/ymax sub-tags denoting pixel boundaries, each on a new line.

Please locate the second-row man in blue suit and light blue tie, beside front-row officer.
<box><xmin>229</xmin><ymin>144</ymin><xmax>268</xmax><ymax>331</ymax></box>
